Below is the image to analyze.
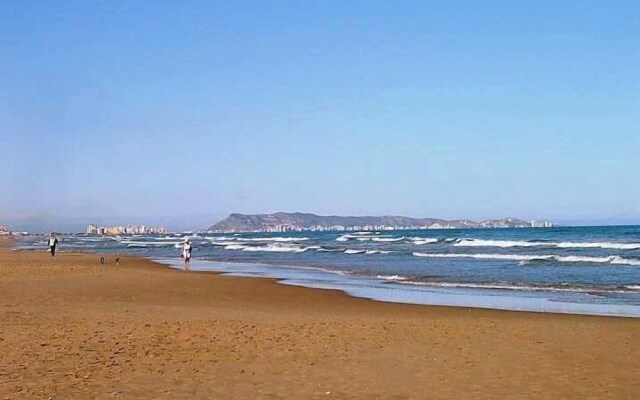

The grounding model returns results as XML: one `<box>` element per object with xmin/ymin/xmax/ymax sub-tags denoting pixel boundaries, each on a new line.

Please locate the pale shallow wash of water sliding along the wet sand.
<box><xmin>154</xmin><ymin>257</ymin><xmax>640</xmax><ymax>318</ymax></box>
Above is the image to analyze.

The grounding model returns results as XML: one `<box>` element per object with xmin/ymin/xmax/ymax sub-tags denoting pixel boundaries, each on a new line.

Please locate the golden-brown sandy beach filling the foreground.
<box><xmin>0</xmin><ymin>249</ymin><xmax>640</xmax><ymax>399</ymax></box>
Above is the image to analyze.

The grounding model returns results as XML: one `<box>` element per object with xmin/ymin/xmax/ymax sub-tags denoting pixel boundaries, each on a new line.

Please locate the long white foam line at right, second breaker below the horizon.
<box><xmin>413</xmin><ymin>252</ymin><xmax>640</xmax><ymax>266</ymax></box>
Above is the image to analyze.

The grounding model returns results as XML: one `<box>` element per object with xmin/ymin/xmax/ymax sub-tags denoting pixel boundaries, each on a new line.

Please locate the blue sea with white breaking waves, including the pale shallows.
<box><xmin>16</xmin><ymin>226</ymin><xmax>640</xmax><ymax>318</ymax></box>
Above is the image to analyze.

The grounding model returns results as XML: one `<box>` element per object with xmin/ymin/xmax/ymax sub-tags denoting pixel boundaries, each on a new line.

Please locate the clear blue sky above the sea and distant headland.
<box><xmin>0</xmin><ymin>0</ymin><xmax>640</xmax><ymax>230</ymax></box>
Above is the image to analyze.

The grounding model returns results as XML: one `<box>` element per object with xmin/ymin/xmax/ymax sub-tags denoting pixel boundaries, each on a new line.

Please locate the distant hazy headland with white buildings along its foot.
<box><xmin>207</xmin><ymin>212</ymin><xmax>551</xmax><ymax>232</ymax></box>
